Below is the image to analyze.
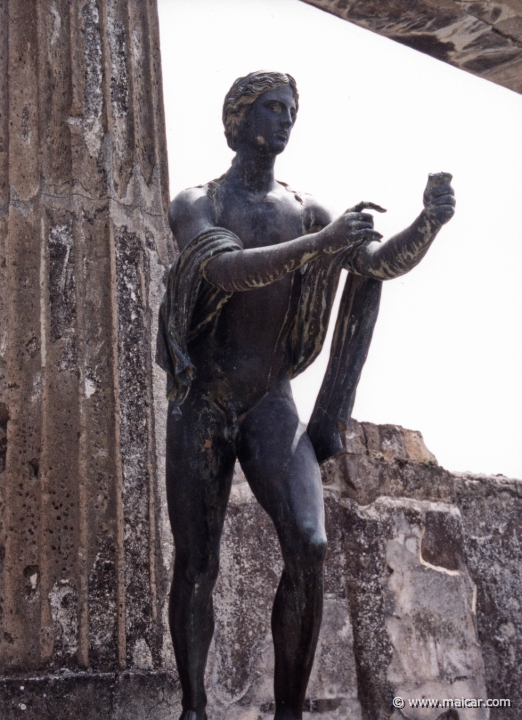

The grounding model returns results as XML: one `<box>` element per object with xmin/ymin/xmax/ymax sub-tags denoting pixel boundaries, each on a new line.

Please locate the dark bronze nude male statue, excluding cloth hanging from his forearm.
<box><xmin>157</xmin><ymin>72</ymin><xmax>455</xmax><ymax>720</ymax></box>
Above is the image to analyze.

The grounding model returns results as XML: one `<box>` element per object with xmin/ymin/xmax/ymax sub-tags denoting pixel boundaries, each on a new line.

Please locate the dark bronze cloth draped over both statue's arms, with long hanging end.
<box><xmin>156</xmin><ymin>228</ymin><xmax>381</xmax><ymax>462</ymax></box>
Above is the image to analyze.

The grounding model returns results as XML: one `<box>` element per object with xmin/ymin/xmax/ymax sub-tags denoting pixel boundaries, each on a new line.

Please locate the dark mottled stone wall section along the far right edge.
<box><xmin>453</xmin><ymin>474</ymin><xmax>522</xmax><ymax>720</ymax></box>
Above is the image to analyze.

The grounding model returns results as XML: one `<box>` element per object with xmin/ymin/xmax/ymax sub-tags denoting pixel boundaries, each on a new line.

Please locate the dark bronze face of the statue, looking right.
<box><xmin>237</xmin><ymin>85</ymin><xmax>297</xmax><ymax>155</ymax></box>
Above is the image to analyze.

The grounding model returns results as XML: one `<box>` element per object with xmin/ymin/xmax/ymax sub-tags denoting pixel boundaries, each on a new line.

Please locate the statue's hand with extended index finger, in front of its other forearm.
<box><xmin>319</xmin><ymin>202</ymin><xmax>386</xmax><ymax>255</ymax></box>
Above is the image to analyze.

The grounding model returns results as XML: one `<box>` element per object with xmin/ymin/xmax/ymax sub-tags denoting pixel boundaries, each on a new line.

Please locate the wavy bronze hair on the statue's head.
<box><xmin>223</xmin><ymin>70</ymin><xmax>299</xmax><ymax>150</ymax></box>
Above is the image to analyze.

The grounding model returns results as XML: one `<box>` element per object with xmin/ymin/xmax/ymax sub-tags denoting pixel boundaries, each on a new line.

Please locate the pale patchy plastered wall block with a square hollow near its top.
<box><xmin>343</xmin><ymin>497</ymin><xmax>489</xmax><ymax>720</ymax></box>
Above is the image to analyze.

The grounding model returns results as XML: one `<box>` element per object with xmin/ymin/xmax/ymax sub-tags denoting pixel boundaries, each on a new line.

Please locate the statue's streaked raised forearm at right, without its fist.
<box><xmin>349</xmin><ymin>210</ymin><xmax>442</xmax><ymax>280</ymax></box>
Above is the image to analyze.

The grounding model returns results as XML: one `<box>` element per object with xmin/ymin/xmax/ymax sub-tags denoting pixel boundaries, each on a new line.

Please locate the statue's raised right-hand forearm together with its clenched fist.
<box><xmin>350</xmin><ymin>173</ymin><xmax>455</xmax><ymax>280</ymax></box>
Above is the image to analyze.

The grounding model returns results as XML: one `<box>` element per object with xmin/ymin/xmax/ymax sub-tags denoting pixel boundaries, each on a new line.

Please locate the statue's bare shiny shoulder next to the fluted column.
<box><xmin>169</xmin><ymin>183</ymin><xmax>215</xmax><ymax>250</ymax></box>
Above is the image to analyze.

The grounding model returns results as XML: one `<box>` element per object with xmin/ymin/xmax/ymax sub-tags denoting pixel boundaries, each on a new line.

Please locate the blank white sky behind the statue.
<box><xmin>159</xmin><ymin>0</ymin><xmax>522</xmax><ymax>478</ymax></box>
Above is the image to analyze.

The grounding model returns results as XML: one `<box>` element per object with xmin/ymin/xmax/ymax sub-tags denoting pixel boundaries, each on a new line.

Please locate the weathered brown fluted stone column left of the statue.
<box><xmin>0</xmin><ymin>0</ymin><xmax>173</xmax><ymax>700</ymax></box>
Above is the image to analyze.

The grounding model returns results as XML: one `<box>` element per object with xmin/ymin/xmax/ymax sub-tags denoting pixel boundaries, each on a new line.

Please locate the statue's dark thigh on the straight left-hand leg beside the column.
<box><xmin>166</xmin><ymin>390</ymin><xmax>236</xmax><ymax>570</ymax></box>
